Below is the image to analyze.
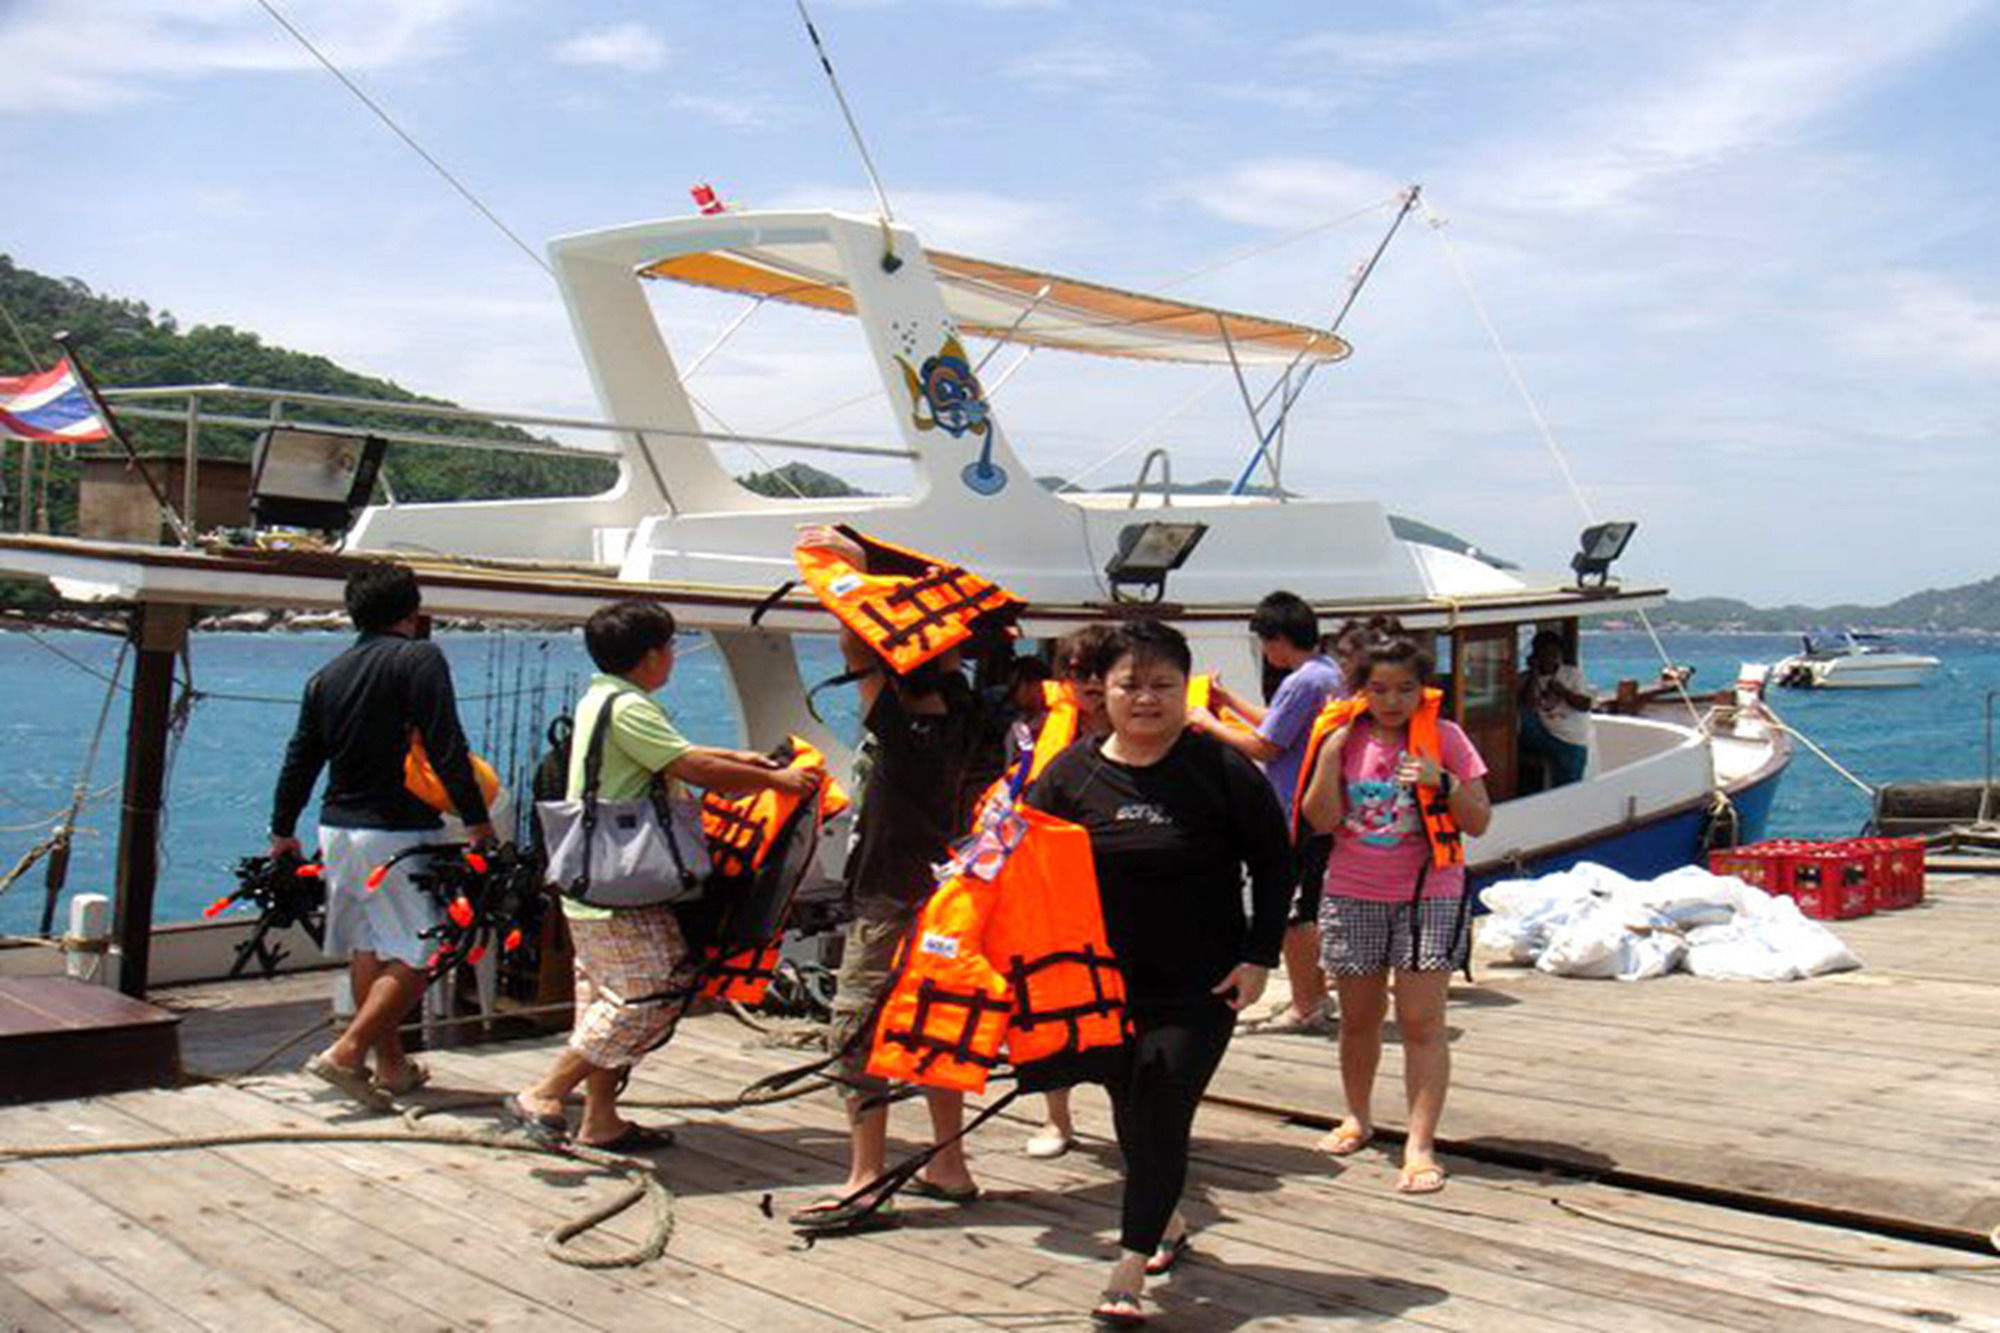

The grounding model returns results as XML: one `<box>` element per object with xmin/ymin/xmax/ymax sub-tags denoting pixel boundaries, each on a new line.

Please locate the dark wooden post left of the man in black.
<box><xmin>114</xmin><ymin>602</ymin><xmax>190</xmax><ymax>999</ymax></box>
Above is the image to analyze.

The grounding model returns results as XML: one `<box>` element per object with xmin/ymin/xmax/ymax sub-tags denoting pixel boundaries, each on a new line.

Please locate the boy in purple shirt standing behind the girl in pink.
<box><xmin>1188</xmin><ymin>592</ymin><xmax>1348</xmax><ymax>1033</ymax></box>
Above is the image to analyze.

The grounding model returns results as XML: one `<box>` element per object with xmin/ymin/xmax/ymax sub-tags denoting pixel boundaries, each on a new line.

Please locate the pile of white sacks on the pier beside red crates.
<box><xmin>1480</xmin><ymin>861</ymin><xmax>1862</xmax><ymax>981</ymax></box>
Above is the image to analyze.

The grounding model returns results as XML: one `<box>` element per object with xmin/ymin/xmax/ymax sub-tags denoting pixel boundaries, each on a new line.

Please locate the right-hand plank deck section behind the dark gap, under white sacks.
<box><xmin>1214</xmin><ymin>877</ymin><xmax>2000</xmax><ymax>1235</ymax></box>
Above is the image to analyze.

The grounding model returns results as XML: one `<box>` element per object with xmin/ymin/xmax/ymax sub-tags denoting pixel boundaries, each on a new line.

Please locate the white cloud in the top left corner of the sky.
<box><xmin>0</xmin><ymin>0</ymin><xmax>478</xmax><ymax>112</ymax></box>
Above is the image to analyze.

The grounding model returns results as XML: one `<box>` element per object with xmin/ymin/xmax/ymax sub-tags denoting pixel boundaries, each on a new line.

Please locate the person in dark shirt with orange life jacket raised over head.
<box><xmin>790</xmin><ymin>524</ymin><xmax>1000</xmax><ymax>1231</ymax></box>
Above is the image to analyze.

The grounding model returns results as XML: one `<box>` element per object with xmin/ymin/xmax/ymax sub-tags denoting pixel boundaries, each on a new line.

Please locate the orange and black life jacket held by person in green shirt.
<box><xmin>700</xmin><ymin>737</ymin><xmax>848</xmax><ymax>1005</ymax></box>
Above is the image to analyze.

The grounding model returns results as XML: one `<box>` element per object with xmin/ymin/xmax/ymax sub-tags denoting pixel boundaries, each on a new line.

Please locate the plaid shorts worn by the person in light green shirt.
<box><xmin>570</xmin><ymin>907</ymin><xmax>696</xmax><ymax>1069</ymax></box>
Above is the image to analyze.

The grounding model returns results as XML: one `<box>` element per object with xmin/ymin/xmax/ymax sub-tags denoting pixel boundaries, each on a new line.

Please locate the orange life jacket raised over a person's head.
<box><xmin>792</xmin><ymin>526</ymin><xmax>1026</xmax><ymax>677</ymax></box>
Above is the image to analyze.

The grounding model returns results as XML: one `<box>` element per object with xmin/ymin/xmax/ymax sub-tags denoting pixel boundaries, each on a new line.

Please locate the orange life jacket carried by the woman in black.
<box><xmin>868</xmin><ymin>809</ymin><xmax>1126</xmax><ymax>1093</ymax></box>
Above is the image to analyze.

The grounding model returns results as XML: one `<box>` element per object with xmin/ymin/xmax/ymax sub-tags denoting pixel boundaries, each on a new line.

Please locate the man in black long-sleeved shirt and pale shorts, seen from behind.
<box><xmin>270</xmin><ymin>564</ymin><xmax>494</xmax><ymax>1107</ymax></box>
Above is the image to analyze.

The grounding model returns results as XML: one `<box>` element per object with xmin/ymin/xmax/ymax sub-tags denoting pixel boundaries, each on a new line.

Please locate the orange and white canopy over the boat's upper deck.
<box><xmin>638</xmin><ymin>242</ymin><xmax>1352</xmax><ymax>366</ymax></box>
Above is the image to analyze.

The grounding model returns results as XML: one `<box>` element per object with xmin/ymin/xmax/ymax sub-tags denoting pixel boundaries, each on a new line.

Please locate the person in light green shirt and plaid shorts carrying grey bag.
<box><xmin>500</xmin><ymin>598</ymin><xmax>818</xmax><ymax>1153</ymax></box>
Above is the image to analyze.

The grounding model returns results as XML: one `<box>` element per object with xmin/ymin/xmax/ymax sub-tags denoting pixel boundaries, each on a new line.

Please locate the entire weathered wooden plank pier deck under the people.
<box><xmin>0</xmin><ymin>879</ymin><xmax>2000</xmax><ymax>1333</ymax></box>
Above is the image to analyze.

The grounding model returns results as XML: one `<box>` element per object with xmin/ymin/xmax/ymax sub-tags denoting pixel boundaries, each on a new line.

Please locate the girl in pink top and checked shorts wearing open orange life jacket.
<box><xmin>1296</xmin><ymin>638</ymin><xmax>1492</xmax><ymax>1195</ymax></box>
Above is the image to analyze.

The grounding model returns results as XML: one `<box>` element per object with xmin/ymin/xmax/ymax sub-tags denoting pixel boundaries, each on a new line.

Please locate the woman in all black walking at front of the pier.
<box><xmin>1028</xmin><ymin>620</ymin><xmax>1292</xmax><ymax>1327</ymax></box>
